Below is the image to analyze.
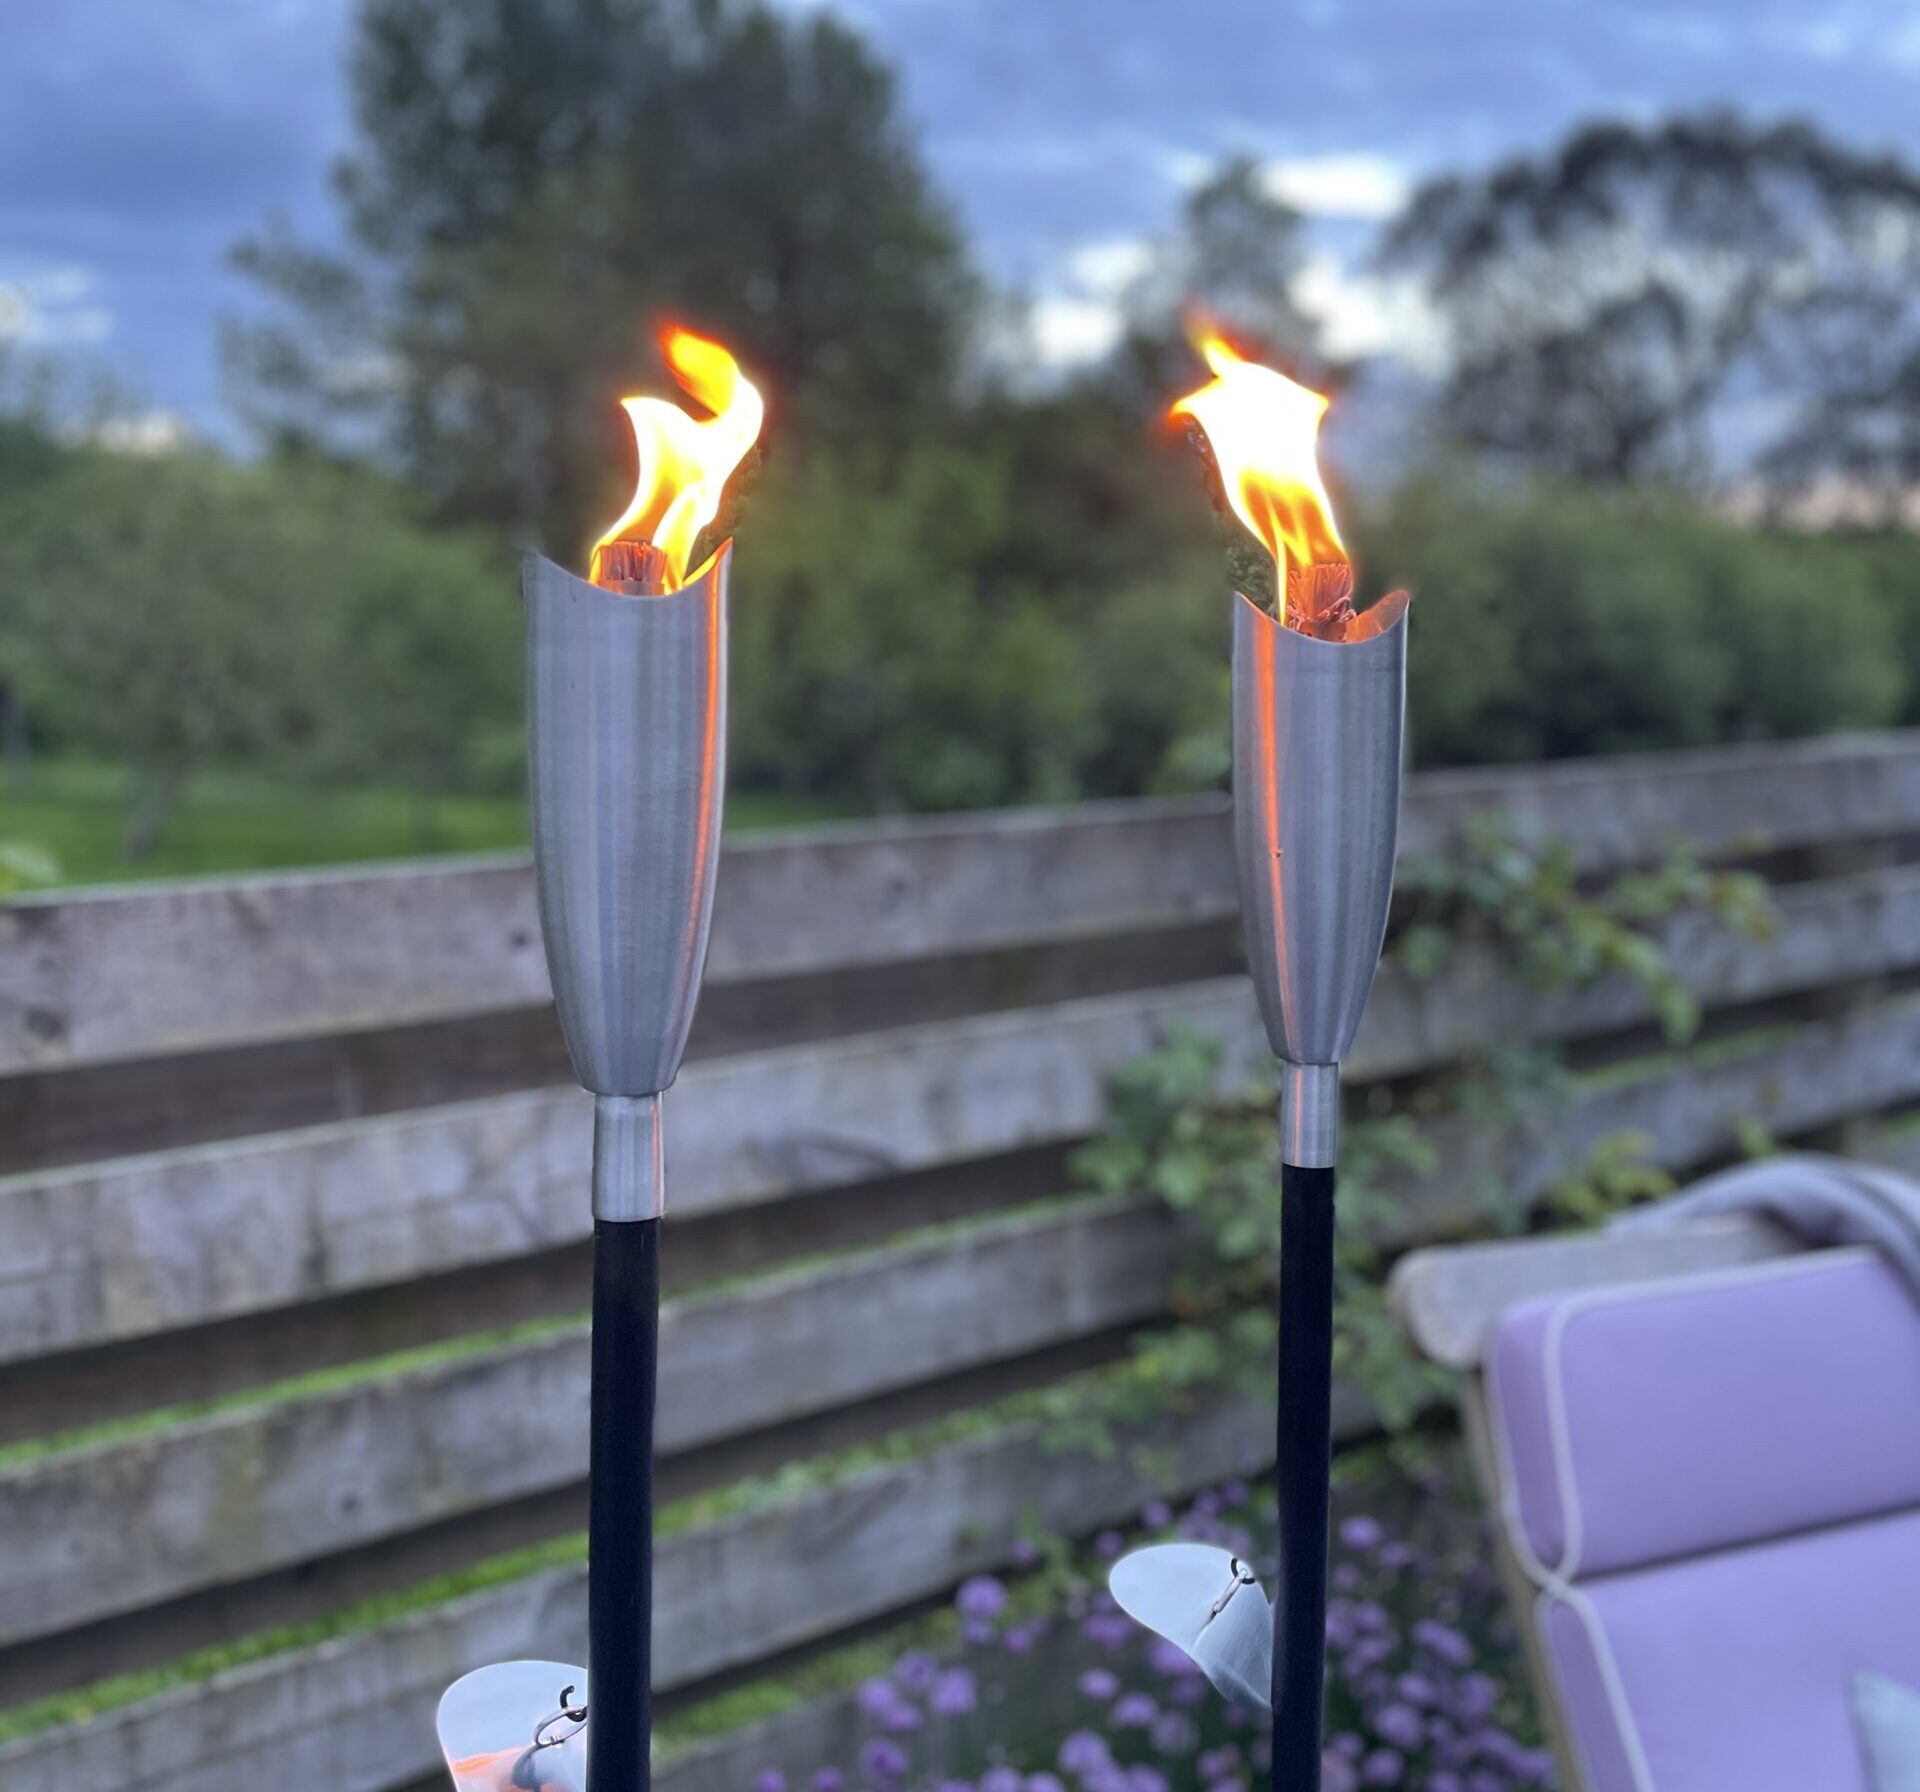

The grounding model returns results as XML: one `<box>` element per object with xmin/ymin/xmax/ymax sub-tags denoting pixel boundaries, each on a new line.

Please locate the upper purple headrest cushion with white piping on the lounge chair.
<box><xmin>1488</xmin><ymin>1250</ymin><xmax>1920</xmax><ymax>1574</ymax></box>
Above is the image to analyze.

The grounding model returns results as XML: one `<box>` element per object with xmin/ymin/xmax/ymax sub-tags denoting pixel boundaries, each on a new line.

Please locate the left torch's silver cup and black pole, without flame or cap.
<box><xmin>524</xmin><ymin>545</ymin><xmax>732</xmax><ymax>1792</ymax></box>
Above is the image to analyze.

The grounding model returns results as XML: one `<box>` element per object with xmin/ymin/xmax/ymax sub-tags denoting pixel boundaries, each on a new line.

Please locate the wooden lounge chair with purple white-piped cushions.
<box><xmin>1396</xmin><ymin>1216</ymin><xmax>1920</xmax><ymax>1792</ymax></box>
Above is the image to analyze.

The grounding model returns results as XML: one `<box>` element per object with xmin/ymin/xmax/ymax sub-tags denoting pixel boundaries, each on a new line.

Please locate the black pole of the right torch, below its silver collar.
<box><xmin>1273</xmin><ymin>1164</ymin><xmax>1334</xmax><ymax>1792</ymax></box>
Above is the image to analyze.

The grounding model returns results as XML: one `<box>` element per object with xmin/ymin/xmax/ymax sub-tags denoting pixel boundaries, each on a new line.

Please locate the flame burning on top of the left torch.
<box><xmin>588</xmin><ymin>325</ymin><xmax>766</xmax><ymax>592</ymax></box>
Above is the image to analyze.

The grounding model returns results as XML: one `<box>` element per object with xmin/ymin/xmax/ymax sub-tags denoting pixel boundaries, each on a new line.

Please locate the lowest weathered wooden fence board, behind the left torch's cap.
<box><xmin>0</xmin><ymin>1398</ymin><xmax>1290</xmax><ymax>1792</ymax></box>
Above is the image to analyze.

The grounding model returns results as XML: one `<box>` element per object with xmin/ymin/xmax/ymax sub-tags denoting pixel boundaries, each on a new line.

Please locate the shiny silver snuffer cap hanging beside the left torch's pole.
<box><xmin>436</xmin><ymin>1661</ymin><xmax>588</xmax><ymax>1792</ymax></box>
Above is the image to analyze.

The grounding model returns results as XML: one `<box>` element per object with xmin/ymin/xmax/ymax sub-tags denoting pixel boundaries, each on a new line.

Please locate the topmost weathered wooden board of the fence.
<box><xmin>0</xmin><ymin>734</ymin><xmax>1920</xmax><ymax>1076</ymax></box>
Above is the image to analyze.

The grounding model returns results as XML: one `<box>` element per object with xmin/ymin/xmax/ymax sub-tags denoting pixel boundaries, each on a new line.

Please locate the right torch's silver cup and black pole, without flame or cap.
<box><xmin>1233</xmin><ymin>597</ymin><xmax>1407</xmax><ymax>1792</ymax></box>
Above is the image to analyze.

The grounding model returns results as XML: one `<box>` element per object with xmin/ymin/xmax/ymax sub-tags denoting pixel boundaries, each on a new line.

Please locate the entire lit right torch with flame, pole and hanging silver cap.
<box><xmin>1114</xmin><ymin>334</ymin><xmax>1407</xmax><ymax>1792</ymax></box>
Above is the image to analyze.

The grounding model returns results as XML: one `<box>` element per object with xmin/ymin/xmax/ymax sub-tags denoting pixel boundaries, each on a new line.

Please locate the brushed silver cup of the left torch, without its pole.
<box><xmin>522</xmin><ymin>544</ymin><xmax>732</xmax><ymax>1097</ymax></box>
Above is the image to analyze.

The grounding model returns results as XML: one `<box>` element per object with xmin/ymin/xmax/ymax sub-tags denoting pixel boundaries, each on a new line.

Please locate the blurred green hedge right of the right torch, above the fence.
<box><xmin>1356</xmin><ymin>478</ymin><xmax>1914</xmax><ymax>764</ymax></box>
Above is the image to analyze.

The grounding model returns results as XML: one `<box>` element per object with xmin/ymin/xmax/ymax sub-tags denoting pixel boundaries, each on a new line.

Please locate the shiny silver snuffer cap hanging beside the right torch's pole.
<box><xmin>1108</xmin><ymin>1542</ymin><xmax>1273</xmax><ymax>1711</ymax></box>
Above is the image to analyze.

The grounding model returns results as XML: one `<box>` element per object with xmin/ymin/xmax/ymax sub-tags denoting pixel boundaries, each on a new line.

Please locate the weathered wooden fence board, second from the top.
<box><xmin>11</xmin><ymin>866</ymin><xmax>1920</xmax><ymax>1362</ymax></box>
